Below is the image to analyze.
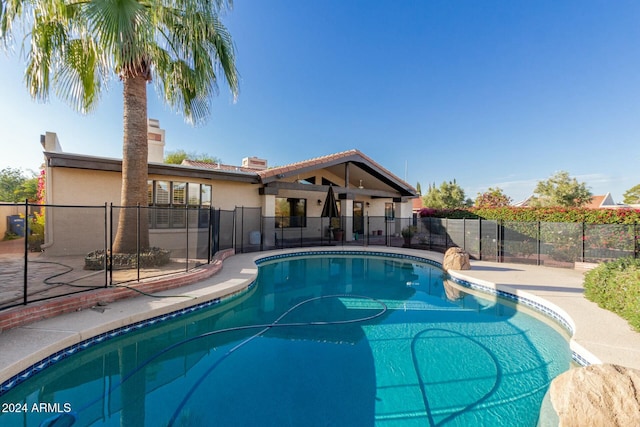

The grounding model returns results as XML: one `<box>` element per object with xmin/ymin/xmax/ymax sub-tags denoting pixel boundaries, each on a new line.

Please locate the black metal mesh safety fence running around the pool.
<box><xmin>0</xmin><ymin>202</ymin><xmax>640</xmax><ymax>310</ymax></box>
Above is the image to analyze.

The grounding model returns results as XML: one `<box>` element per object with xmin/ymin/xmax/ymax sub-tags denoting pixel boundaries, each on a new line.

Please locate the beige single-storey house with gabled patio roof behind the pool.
<box><xmin>41</xmin><ymin>120</ymin><xmax>418</xmax><ymax>254</ymax></box>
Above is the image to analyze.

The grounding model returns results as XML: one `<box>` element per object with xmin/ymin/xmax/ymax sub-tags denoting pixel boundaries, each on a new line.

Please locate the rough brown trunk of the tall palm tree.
<box><xmin>113</xmin><ymin>75</ymin><xmax>149</xmax><ymax>253</ymax></box>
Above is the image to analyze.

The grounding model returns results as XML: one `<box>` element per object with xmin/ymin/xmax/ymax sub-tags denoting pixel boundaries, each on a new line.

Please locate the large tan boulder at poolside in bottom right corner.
<box><xmin>549</xmin><ymin>365</ymin><xmax>640</xmax><ymax>427</ymax></box>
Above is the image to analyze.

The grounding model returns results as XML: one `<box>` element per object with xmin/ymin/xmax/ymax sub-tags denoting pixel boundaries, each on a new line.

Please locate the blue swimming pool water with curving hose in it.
<box><xmin>0</xmin><ymin>255</ymin><xmax>571</xmax><ymax>427</ymax></box>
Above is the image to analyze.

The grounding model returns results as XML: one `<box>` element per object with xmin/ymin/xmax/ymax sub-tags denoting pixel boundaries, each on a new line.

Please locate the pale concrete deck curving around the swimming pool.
<box><xmin>0</xmin><ymin>247</ymin><xmax>640</xmax><ymax>390</ymax></box>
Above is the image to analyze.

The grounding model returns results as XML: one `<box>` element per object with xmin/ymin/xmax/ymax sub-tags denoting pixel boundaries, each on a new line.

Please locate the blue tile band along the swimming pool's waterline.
<box><xmin>0</xmin><ymin>250</ymin><xmax>590</xmax><ymax>396</ymax></box>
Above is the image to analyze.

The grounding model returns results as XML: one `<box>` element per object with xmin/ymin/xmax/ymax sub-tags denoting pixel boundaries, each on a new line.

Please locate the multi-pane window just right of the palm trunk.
<box><xmin>147</xmin><ymin>181</ymin><xmax>212</xmax><ymax>228</ymax></box>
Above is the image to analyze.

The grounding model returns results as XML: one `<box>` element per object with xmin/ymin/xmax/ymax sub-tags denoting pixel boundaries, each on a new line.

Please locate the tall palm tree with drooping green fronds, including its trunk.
<box><xmin>0</xmin><ymin>0</ymin><xmax>238</xmax><ymax>253</ymax></box>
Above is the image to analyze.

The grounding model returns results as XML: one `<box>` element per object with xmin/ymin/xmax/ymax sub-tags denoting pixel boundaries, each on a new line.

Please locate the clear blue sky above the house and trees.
<box><xmin>0</xmin><ymin>0</ymin><xmax>640</xmax><ymax>202</ymax></box>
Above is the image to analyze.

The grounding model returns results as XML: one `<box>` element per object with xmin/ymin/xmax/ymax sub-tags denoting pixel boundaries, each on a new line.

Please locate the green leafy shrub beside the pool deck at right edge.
<box><xmin>584</xmin><ymin>258</ymin><xmax>640</xmax><ymax>331</ymax></box>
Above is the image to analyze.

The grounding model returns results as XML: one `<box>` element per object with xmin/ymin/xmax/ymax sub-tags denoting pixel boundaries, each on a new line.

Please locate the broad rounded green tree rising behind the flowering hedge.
<box><xmin>532</xmin><ymin>171</ymin><xmax>593</xmax><ymax>207</ymax></box>
